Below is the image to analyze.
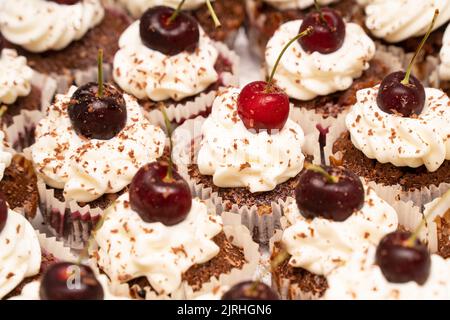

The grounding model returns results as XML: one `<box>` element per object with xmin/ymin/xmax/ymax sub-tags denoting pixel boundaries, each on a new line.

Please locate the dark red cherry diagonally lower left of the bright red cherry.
<box><xmin>130</xmin><ymin>161</ymin><xmax>192</xmax><ymax>226</ymax></box>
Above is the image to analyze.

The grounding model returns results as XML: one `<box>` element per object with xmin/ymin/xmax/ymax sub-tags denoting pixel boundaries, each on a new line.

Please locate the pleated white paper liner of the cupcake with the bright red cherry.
<box><xmin>172</xmin><ymin>117</ymin><xmax>320</xmax><ymax>244</ymax></box>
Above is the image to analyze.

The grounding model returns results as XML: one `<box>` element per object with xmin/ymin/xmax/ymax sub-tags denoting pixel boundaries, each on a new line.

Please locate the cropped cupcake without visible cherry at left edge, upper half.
<box><xmin>0</xmin><ymin>49</ymin><xmax>56</xmax><ymax>151</ymax></box>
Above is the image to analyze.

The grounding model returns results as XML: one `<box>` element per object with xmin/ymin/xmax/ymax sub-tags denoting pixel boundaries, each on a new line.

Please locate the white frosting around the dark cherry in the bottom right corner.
<box><xmin>324</xmin><ymin>246</ymin><xmax>450</xmax><ymax>300</ymax></box>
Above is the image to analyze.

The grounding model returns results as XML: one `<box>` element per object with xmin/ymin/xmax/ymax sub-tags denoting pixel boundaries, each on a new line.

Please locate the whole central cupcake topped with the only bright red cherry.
<box><xmin>174</xmin><ymin>83</ymin><xmax>310</xmax><ymax>243</ymax></box>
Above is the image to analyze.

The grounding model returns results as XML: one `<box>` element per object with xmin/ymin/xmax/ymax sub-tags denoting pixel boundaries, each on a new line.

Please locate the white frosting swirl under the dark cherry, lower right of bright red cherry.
<box><xmin>282</xmin><ymin>187</ymin><xmax>398</xmax><ymax>275</ymax></box>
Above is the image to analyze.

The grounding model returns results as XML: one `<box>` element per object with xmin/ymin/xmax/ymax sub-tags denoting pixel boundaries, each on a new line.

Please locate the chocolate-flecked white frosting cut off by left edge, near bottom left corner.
<box><xmin>0</xmin><ymin>210</ymin><xmax>41</xmax><ymax>298</ymax></box>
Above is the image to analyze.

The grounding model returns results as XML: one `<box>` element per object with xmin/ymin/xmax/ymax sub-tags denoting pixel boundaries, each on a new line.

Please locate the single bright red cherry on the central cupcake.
<box><xmin>237</xmin><ymin>81</ymin><xmax>289</xmax><ymax>132</ymax></box>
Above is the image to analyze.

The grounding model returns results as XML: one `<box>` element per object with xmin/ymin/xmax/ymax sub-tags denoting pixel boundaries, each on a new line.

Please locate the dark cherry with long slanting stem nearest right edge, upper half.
<box><xmin>377</xmin><ymin>71</ymin><xmax>425</xmax><ymax>117</ymax></box>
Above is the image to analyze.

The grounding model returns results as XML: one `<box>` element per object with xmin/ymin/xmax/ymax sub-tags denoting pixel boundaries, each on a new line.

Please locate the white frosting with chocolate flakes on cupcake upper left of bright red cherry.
<box><xmin>114</xmin><ymin>21</ymin><xmax>219</xmax><ymax>101</ymax></box>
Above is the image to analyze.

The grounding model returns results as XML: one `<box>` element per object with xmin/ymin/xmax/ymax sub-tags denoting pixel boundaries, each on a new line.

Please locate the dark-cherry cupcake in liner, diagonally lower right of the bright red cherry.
<box><xmin>271</xmin><ymin>166</ymin><xmax>398</xmax><ymax>299</ymax></box>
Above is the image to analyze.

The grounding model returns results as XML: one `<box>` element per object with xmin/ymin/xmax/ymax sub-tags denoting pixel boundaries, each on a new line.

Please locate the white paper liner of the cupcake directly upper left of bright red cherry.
<box><xmin>144</xmin><ymin>42</ymin><xmax>243</xmax><ymax>128</ymax></box>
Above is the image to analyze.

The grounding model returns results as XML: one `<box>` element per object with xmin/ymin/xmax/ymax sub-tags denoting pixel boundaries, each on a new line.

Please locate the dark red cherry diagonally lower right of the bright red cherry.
<box><xmin>295</xmin><ymin>165</ymin><xmax>364</xmax><ymax>221</ymax></box>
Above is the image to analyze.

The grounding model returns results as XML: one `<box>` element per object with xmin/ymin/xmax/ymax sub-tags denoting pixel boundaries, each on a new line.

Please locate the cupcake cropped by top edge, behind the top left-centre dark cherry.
<box><xmin>112</xmin><ymin>0</ymin><xmax>245</xmax><ymax>47</ymax></box>
